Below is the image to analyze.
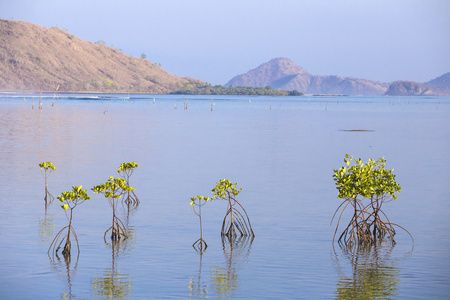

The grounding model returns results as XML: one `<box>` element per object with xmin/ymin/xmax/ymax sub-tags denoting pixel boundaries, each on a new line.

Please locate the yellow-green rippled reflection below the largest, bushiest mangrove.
<box><xmin>334</xmin><ymin>242</ymin><xmax>406</xmax><ymax>299</ymax></box>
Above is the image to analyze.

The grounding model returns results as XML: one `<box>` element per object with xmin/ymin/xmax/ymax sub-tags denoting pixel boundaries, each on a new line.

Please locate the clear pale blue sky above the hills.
<box><xmin>0</xmin><ymin>0</ymin><xmax>450</xmax><ymax>85</ymax></box>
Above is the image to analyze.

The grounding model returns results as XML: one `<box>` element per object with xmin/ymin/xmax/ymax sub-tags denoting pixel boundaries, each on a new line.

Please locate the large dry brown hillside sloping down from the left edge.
<box><xmin>0</xmin><ymin>19</ymin><xmax>205</xmax><ymax>94</ymax></box>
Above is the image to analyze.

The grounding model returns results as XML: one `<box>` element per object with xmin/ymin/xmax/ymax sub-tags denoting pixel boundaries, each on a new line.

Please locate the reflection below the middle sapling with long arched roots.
<box><xmin>211</xmin><ymin>236</ymin><xmax>254</xmax><ymax>298</ymax></box>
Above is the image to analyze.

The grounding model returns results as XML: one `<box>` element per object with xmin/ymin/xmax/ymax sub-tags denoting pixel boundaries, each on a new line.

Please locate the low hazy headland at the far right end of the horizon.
<box><xmin>385</xmin><ymin>81</ymin><xmax>450</xmax><ymax>96</ymax></box>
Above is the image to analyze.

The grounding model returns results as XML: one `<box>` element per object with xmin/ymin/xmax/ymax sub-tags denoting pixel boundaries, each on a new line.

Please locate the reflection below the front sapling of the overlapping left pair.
<box><xmin>92</xmin><ymin>236</ymin><xmax>133</xmax><ymax>299</ymax></box>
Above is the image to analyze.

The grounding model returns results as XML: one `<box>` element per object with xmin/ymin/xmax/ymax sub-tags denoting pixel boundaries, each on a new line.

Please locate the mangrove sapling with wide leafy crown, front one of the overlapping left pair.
<box><xmin>92</xmin><ymin>176</ymin><xmax>134</xmax><ymax>242</ymax></box>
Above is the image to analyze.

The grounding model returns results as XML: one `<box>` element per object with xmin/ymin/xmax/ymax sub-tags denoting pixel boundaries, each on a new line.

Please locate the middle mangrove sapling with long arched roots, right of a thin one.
<box><xmin>212</xmin><ymin>179</ymin><xmax>255</xmax><ymax>239</ymax></box>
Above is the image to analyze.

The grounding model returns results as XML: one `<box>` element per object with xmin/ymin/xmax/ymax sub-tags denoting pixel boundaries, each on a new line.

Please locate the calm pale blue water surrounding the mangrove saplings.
<box><xmin>0</xmin><ymin>95</ymin><xmax>450</xmax><ymax>299</ymax></box>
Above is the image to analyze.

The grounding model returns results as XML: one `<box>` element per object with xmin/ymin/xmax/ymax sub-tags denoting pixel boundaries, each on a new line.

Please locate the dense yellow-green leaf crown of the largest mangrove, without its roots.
<box><xmin>333</xmin><ymin>154</ymin><xmax>401</xmax><ymax>199</ymax></box>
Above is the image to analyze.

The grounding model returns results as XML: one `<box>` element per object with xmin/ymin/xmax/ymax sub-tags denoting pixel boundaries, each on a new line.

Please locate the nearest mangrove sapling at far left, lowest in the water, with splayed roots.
<box><xmin>47</xmin><ymin>185</ymin><xmax>91</xmax><ymax>256</ymax></box>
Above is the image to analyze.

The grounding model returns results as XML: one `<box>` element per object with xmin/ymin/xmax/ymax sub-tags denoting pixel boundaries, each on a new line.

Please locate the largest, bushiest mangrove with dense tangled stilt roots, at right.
<box><xmin>331</xmin><ymin>154</ymin><xmax>412</xmax><ymax>248</ymax></box>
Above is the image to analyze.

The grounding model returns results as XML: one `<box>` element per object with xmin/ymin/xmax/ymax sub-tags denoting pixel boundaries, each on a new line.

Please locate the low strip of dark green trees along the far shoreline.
<box><xmin>171</xmin><ymin>84</ymin><xmax>303</xmax><ymax>96</ymax></box>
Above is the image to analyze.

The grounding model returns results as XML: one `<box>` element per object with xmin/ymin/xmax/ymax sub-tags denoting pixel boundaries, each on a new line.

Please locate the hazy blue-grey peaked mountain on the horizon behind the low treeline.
<box><xmin>225</xmin><ymin>58</ymin><xmax>388</xmax><ymax>95</ymax></box>
